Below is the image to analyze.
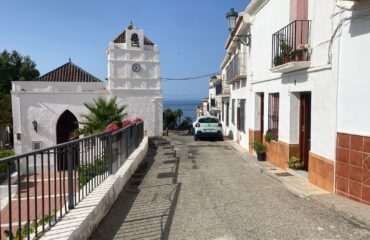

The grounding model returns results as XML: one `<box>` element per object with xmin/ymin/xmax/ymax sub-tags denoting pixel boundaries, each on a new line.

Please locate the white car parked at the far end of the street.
<box><xmin>193</xmin><ymin>116</ymin><xmax>224</xmax><ymax>141</ymax></box>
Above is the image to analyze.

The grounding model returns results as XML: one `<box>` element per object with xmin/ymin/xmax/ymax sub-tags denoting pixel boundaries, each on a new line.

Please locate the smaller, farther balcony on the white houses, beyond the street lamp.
<box><xmin>226</xmin><ymin>53</ymin><xmax>247</xmax><ymax>84</ymax></box>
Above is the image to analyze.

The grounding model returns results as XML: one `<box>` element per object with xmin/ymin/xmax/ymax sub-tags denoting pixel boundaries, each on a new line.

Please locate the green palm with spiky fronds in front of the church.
<box><xmin>73</xmin><ymin>97</ymin><xmax>127</xmax><ymax>136</ymax></box>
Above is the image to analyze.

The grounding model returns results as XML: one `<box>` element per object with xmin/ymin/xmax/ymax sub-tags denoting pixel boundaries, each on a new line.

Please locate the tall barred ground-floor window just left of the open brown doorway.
<box><xmin>268</xmin><ymin>93</ymin><xmax>279</xmax><ymax>140</ymax></box>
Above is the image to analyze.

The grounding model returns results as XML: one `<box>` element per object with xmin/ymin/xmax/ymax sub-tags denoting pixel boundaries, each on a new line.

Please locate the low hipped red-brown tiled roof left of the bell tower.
<box><xmin>37</xmin><ymin>62</ymin><xmax>101</xmax><ymax>82</ymax></box>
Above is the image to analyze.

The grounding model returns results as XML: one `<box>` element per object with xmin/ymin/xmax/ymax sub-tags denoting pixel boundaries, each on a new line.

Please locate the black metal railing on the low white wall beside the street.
<box><xmin>0</xmin><ymin>122</ymin><xmax>144</xmax><ymax>239</ymax></box>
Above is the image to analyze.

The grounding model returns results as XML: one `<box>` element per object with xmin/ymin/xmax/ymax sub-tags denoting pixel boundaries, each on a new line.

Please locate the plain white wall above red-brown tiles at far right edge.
<box><xmin>338</xmin><ymin>1</ymin><xmax>370</xmax><ymax>136</ymax></box>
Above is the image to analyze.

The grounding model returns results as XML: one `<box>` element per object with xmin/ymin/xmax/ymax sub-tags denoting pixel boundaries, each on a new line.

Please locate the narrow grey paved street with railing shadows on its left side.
<box><xmin>91</xmin><ymin>136</ymin><xmax>370</xmax><ymax>239</ymax></box>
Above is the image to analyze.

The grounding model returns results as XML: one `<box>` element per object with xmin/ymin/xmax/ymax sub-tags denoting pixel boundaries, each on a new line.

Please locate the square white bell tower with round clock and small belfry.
<box><xmin>107</xmin><ymin>24</ymin><xmax>163</xmax><ymax>136</ymax></box>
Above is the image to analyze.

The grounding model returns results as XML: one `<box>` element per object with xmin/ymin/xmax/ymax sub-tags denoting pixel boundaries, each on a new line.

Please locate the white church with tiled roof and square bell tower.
<box><xmin>12</xmin><ymin>24</ymin><xmax>163</xmax><ymax>154</ymax></box>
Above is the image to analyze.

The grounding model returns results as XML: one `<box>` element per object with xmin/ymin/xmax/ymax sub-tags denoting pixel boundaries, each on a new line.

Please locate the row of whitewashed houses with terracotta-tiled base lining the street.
<box><xmin>221</xmin><ymin>0</ymin><xmax>370</xmax><ymax>204</ymax></box>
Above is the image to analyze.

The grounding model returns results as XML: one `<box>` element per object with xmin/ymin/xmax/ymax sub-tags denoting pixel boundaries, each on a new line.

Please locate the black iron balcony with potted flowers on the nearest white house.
<box><xmin>270</xmin><ymin>20</ymin><xmax>311</xmax><ymax>73</ymax></box>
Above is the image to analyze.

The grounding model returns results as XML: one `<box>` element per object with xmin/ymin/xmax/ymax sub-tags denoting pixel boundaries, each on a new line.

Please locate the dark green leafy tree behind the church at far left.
<box><xmin>0</xmin><ymin>50</ymin><xmax>40</xmax><ymax>94</ymax></box>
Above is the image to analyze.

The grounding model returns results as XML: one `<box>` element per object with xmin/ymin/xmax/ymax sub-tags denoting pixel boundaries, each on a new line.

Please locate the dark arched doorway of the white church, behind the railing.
<box><xmin>56</xmin><ymin>110</ymin><xmax>78</xmax><ymax>171</ymax></box>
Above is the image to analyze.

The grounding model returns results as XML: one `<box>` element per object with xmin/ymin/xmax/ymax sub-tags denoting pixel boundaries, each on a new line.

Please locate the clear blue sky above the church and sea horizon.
<box><xmin>0</xmin><ymin>0</ymin><xmax>249</xmax><ymax>100</ymax></box>
